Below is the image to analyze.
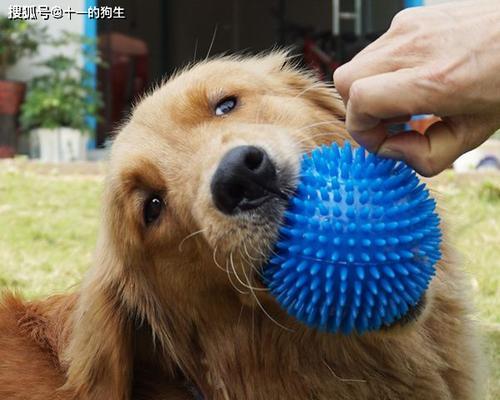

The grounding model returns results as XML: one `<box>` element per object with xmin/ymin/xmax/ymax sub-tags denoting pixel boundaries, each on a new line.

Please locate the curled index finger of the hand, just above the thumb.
<box><xmin>346</xmin><ymin>68</ymin><xmax>432</xmax><ymax>134</ymax></box>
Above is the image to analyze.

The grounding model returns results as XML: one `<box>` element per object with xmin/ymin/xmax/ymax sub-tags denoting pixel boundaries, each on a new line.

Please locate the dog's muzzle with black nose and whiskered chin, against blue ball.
<box><xmin>207</xmin><ymin>146</ymin><xmax>299</xmax><ymax>286</ymax></box>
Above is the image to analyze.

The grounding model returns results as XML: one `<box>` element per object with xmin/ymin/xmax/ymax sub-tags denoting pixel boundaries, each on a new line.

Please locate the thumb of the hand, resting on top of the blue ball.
<box><xmin>378</xmin><ymin>121</ymin><xmax>467</xmax><ymax>176</ymax></box>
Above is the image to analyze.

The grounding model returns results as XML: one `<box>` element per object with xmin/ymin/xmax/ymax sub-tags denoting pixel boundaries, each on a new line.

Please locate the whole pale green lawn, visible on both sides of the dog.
<box><xmin>0</xmin><ymin>162</ymin><xmax>500</xmax><ymax>400</ymax></box>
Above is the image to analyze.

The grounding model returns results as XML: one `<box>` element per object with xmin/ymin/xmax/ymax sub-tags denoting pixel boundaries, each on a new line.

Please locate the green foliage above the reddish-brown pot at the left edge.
<box><xmin>0</xmin><ymin>15</ymin><xmax>47</xmax><ymax>79</ymax></box>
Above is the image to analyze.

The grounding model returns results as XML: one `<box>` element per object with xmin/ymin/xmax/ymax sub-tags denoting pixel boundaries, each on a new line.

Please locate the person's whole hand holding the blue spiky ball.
<box><xmin>334</xmin><ymin>0</ymin><xmax>500</xmax><ymax>176</ymax></box>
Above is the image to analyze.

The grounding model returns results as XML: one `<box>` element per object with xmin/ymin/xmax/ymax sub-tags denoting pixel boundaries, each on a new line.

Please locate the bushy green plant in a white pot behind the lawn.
<box><xmin>20</xmin><ymin>33</ymin><xmax>102</xmax><ymax>162</ymax></box>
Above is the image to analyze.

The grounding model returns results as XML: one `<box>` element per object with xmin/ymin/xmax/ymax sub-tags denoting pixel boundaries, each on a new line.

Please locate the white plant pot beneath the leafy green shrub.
<box><xmin>30</xmin><ymin>127</ymin><xmax>88</xmax><ymax>163</ymax></box>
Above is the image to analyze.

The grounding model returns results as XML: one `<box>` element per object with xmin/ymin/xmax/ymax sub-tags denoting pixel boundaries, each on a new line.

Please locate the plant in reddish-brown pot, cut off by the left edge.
<box><xmin>0</xmin><ymin>15</ymin><xmax>45</xmax><ymax>158</ymax></box>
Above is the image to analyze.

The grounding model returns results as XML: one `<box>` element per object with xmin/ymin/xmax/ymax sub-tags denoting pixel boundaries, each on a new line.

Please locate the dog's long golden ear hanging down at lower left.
<box><xmin>65</xmin><ymin>239</ymin><xmax>133</xmax><ymax>400</ymax></box>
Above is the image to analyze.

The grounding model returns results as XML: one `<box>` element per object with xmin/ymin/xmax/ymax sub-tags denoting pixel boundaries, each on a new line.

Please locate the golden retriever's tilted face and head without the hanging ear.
<box><xmin>106</xmin><ymin>53</ymin><xmax>345</xmax><ymax>294</ymax></box>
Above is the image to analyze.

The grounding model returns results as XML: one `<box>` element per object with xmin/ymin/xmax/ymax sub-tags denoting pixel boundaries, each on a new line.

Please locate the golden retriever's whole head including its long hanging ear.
<box><xmin>68</xmin><ymin>52</ymin><xmax>347</xmax><ymax>396</ymax></box>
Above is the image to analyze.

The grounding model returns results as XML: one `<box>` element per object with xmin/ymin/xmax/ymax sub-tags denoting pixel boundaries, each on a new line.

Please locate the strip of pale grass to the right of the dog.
<box><xmin>435</xmin><ymin>171</ymin><xmax>500</xmax><ymax>400</ymax></box>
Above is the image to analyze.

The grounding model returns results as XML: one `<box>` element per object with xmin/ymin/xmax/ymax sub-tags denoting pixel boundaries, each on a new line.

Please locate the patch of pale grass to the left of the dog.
<box><xmin>0</xmin><ymin>164</ymin><xmax>102</xmax><ymax>298</ymax></box>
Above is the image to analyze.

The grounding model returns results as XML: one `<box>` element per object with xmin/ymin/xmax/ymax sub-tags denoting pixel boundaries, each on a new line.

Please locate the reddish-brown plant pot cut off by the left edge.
<box><xmin>0</xmin><ymin>80</ymin><xmax>26</xmax><ymax>158</ymax></box>
